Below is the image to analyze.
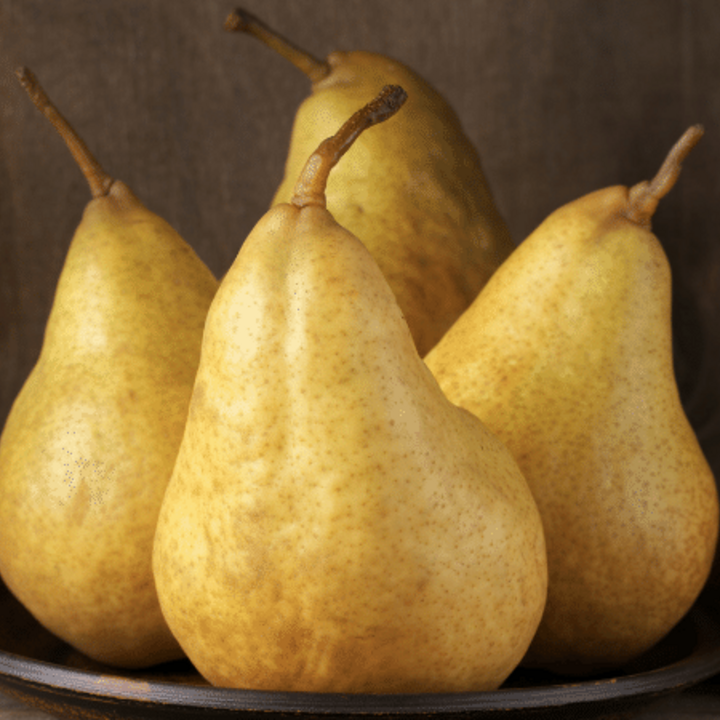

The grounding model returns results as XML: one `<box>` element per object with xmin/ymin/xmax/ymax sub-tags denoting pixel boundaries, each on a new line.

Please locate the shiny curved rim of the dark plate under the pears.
<box><xmin>0</xmin><ymin>603</ymin><xmax>720</xmax><ymax>715</ymax></box>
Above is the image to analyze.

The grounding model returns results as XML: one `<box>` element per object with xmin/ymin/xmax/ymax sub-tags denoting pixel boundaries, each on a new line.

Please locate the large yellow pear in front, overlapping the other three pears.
<box><xmin>153</xmin><ymin>86</ymin><xmax>547</xmax><ymax>693</ymax></box>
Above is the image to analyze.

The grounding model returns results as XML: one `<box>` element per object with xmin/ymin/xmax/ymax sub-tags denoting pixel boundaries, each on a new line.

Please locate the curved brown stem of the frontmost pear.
<box><xmin>290</xmin><ymin>85</ymin><xmax>407</xmax><ymax>208</ymax></box>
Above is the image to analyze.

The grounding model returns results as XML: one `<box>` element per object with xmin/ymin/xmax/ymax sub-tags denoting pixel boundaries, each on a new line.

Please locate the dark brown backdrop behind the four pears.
<box><xmin>0</xmin><ymin>0</ymin><xmax>720</xmax><ymax>474</ymax></box>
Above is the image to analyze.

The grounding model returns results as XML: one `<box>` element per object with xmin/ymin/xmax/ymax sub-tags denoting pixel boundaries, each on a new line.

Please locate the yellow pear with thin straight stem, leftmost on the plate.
<box><xmin>0</xmin><ymin>69</ymin><xmax>218</xmax><ymax>668</ymax></box>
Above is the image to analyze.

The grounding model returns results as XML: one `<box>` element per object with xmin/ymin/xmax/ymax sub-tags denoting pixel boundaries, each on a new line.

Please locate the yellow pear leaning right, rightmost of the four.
<box><xmin>426</xmin><ymin>126</ymin><xmax>718</xmax><ymax>675</ymax></box>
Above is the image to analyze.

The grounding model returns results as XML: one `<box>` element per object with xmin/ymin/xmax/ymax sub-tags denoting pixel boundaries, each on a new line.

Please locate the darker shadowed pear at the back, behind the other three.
<box><xmin>225</xmin><ymin>9</ymin><xmax>515</xmax><ymax>356</ymax></box>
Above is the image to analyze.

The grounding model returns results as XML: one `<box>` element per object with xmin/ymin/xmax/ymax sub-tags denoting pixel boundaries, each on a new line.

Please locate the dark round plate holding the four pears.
<box><xmin>0</xmin><ymin>585</ymin><xmax>720</xmax><ymax>720</ymax></box>
